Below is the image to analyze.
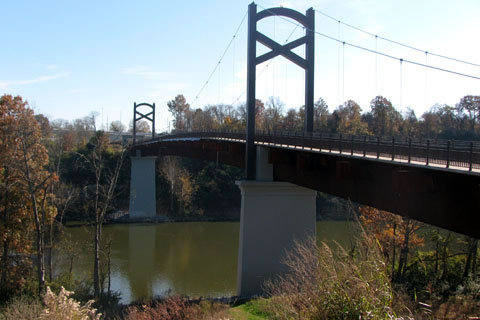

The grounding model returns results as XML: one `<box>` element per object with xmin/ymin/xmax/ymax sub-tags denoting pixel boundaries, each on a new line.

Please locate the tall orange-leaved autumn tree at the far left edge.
<box><xmin>0</xmin><ymin>95</ymin><xmax>57</xmax><ymax>293</ymax></box>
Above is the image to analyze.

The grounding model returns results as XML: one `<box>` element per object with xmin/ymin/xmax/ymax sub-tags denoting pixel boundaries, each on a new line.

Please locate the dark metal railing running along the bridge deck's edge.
<box><xmin>138</xmin><ymin>130</ymin><xmax>480</xmax><ymax>171</ymax></box>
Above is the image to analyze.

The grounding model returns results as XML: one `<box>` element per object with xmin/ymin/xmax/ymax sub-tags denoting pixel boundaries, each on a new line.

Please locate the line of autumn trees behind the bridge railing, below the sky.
<box><xmin>167</xmin><ymin>94</ymin><xmax>480</xmax><ymax>140</ymax></box>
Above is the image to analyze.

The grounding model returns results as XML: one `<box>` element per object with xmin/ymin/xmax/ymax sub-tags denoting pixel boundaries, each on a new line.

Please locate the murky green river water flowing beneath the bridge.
<box><xmin>61</xmin><ymin>221</ymin><xmax>355</xmax><ymax>303</ymax></box>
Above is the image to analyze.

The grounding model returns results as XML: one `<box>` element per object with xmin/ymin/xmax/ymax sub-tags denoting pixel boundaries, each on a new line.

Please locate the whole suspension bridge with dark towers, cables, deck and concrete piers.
<box><xmin>126</xmin><ymin>3</ymin><xmax>480</xmax><ymax>295</ymax></box>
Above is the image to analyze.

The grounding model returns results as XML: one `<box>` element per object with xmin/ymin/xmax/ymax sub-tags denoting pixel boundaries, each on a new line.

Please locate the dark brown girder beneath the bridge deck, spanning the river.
<box><xmin>135</xmin><ymin>139</ymin><xmax>480</xmax><ymax>238</ymax></box>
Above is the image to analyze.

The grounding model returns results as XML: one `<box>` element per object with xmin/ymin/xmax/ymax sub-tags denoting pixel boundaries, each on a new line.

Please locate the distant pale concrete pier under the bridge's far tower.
<box><xmin>129</xmin><ymin>157</ymin><xmax>157</xmax><ymax>218</ymax></box>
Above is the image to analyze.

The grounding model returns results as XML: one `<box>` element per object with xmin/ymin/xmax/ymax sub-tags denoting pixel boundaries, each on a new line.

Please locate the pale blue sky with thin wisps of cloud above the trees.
<box><xmin>0</xmin><ymin>0</ymin><xmax>480</xmax><ymax>130</ymax></box>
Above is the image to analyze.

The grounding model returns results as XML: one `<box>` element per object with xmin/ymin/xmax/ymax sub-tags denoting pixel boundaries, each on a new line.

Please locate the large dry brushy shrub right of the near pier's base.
<box><xmin>262</xmin><ymin>238</ymin><xmax>393</xmax><ymax>319</ymax></box>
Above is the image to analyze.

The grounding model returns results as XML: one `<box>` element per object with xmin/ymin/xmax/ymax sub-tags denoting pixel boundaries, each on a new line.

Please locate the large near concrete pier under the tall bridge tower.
<box><xmin>236</xmin><ymin>181</ymin><xmax>317</xmax><ymax>296</ymax></box>
